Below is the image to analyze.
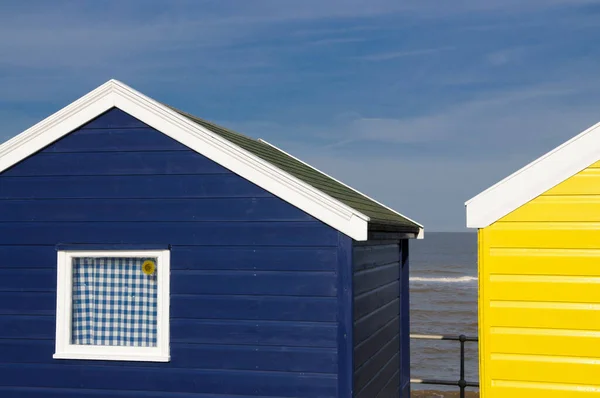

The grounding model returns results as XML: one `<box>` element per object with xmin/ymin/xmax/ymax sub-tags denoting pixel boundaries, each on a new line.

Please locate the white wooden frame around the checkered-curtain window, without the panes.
<box><xmin>53</xmin><ymin>250</ymin><xmax>170</xmax><ymax>362</ymax></box>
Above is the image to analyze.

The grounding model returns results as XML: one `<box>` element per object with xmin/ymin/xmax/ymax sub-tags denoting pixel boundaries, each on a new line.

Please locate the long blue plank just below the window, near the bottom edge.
<box><xmin>0</xmin><ymin>363</ymin><xmax>337</xmax><ymax>398</ymax></box>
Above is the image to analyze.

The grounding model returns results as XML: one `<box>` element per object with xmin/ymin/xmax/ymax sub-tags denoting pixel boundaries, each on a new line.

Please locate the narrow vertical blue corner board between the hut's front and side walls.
<box><xmin>337</xmin><ymin>232</ymin><xmax>354</xmax><ymax>397</ymax></box>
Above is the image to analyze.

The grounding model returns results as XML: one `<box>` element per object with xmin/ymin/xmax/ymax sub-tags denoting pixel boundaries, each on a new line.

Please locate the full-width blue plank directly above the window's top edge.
<box><xmin>0</xmin><ymin>222</ymin><xmax>337</xmax><ymax>247</ymax></box>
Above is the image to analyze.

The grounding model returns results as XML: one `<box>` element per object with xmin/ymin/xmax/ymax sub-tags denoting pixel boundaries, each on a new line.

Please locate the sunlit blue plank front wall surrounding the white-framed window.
<box><xmin>0</xmin><ymin>110</ymin><xmax>342</xmax><ymax>398</ymax></box>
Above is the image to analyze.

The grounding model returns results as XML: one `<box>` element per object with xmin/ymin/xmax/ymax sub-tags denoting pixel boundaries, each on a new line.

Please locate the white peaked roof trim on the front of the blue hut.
<box><xmin>0</xmin><ymin>80</ymin><xmax>369</xmax><ymax>241</ymax></box>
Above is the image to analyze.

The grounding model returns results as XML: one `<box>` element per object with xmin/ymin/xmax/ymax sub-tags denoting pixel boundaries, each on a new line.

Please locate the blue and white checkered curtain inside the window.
<box><xmin>71</xmin><ymin>257</ymin><xmax>157</xmax><ymax>347</ymax></box>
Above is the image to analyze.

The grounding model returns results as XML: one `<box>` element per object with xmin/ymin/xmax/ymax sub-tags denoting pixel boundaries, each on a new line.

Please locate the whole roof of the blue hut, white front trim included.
<box><xmin>0</xmin><ymin>80</ymin><xmax>423</xmax><ymax>240</ymax></box>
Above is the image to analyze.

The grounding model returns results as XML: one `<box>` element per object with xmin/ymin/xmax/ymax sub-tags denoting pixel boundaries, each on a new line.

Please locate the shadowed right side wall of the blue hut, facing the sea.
<box><xmin>353</xmin><ymin>241</ymin><xmax>410</xmax><ymax>398</ymax></box>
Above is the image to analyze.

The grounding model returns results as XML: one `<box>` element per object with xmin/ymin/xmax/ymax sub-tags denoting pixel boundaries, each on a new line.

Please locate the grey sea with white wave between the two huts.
<box><xmin>409</xmin><ymin>232</ymin><xmax>478</xmax><ymax>391</ymax></box>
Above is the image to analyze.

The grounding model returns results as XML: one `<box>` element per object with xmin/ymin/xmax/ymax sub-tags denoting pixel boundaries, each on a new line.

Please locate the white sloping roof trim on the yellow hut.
<box><xmin>465</xmin><ymin>119</ymin><xmax>600</xmax><ymax>228</ymax></box>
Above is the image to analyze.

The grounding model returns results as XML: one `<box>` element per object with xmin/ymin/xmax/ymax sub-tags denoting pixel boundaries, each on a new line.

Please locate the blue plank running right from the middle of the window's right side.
<box><xmin>171</xmin><ymin>295</ymin><xmax>337</xmax><ymax>322</ymax></box>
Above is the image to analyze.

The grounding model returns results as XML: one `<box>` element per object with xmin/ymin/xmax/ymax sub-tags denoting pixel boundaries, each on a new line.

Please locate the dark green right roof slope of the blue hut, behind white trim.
<box><xmin>171</xmin><ymin>107</ymin><xmax>423</xmax><ymax>233</ymax></box>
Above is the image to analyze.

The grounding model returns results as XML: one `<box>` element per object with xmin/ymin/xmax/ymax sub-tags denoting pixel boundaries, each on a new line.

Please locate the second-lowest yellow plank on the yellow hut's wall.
<box><xmin>489</xmin><ymin>354</ymin><xmax>600</xmax><ymax>385</ymax></box>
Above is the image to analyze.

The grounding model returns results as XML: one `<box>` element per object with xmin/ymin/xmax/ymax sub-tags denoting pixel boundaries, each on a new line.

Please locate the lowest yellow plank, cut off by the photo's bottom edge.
<box><xmin>484</xmin><ymin>380</ymin><xmax>600</xmax><ymax>398</ymax></box>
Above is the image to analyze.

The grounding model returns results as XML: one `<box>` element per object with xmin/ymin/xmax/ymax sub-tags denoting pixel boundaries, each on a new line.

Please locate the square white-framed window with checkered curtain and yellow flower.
<box><xmin>54</xmin><ymin>250</ymin><xmax>169</xmax><ymax>362</ymax></box>
